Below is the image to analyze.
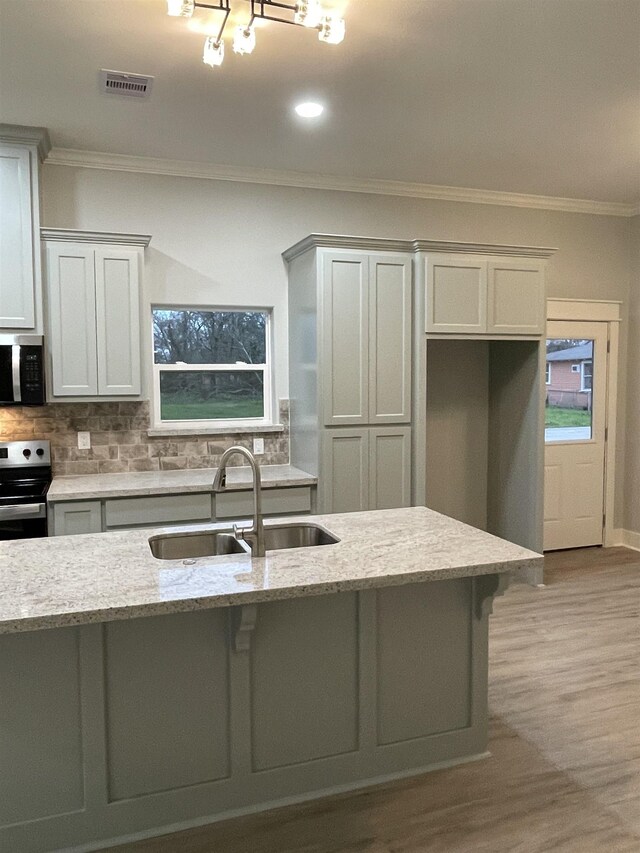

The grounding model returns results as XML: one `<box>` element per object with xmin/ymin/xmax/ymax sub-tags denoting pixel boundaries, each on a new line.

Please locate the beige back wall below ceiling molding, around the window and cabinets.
<box><xmin>42</xmin><ymin>164</ymin><xmax>630</xmax><ymax>513</ymax></box>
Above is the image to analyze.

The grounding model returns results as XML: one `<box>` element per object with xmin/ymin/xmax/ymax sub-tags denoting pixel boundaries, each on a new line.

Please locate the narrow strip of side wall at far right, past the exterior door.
<box><xmin>623</xmin><ymin>216</ymin><xmax>640</xmax><ymax>532</ymax></box>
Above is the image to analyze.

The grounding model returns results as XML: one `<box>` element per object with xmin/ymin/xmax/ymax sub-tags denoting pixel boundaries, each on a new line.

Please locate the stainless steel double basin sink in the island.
<box><xmin>149</xmin><ymin>522</ymin><xmax>340</xmax><ymax>560</ymax></box>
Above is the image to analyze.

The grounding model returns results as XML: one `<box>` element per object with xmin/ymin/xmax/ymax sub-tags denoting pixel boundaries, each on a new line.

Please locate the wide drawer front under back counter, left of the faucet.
<box><xmin>105</xmin><ymin>492</ymin><xmax>211</xmax><ymax>527</ymax></box>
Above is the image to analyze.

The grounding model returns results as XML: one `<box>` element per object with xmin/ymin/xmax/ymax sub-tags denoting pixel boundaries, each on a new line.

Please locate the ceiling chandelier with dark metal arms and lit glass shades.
<box><xmin>167</xmin><ymin>0</ymin><xmax>345</xmax><ymax>68</ymax></box>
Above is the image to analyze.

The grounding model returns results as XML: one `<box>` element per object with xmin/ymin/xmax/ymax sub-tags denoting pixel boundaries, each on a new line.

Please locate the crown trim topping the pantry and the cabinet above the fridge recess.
<box><xmin>282</xmin><ymin>234</ymin><xmax>557</xmax><ymax>262</ymax></box>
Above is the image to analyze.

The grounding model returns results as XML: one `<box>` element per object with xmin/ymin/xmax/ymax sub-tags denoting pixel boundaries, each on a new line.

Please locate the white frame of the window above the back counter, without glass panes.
<box><xmin>150</xmin><ymin>303</ymin><xmax>275</xmax><ymax>434</ymax></box>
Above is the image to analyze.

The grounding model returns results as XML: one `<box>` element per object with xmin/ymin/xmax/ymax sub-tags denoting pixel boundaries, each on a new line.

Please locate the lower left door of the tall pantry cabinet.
<box><xmin>319</xmin><ymin>429</ymin><xmax>370</xmax><ymax>512</ymax></box>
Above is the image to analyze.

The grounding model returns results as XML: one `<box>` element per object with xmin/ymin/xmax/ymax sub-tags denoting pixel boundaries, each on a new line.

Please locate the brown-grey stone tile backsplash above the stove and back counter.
<box><xmin>0</xmin><ymin>400</ymin><xmax>289</xmax><ymax>476</ymax></box>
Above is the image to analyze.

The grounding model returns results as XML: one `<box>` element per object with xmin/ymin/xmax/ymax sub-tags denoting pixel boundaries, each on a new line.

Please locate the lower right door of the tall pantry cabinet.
<box><xmin>369</xmin><ymin>427</ymin><xmax>411</xmax><ymax>509</ymax></box>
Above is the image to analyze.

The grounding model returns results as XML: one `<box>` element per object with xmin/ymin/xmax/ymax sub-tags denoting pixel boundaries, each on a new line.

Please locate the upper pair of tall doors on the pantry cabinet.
<box><xmin>319</xmin><ymin>251</ymin><xmax>412</xmax><ymax>426</ymax></box>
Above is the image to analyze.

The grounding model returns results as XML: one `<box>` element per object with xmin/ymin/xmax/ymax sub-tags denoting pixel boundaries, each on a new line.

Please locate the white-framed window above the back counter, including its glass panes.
<box><xmin>152</xmin><ymin>307</ymin><xmax>271</xmax><ymax>429</ymax></box>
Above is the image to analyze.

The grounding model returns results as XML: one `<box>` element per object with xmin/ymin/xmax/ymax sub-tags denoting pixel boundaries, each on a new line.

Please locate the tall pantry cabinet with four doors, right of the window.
<box><xmin>284</xmin><ymin>238</ymin><xmax>413</xmax><ymax>512</ymax></box>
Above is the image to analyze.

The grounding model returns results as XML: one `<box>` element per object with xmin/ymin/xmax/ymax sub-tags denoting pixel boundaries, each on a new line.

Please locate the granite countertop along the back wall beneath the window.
<box><xmin>47</xmin><ymin>465</ymin><xmax>318</xmax><ymax>503</ymax></box>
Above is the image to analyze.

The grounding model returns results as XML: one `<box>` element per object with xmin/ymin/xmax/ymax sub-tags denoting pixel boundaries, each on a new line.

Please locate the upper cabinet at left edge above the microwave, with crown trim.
<box><xmin>0</xmin><ymin>125</ymin><xmax>51</xmax><ymax>334</ymax></box>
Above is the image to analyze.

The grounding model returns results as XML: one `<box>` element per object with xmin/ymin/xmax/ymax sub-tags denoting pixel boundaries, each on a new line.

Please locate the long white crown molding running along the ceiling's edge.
<box><xmin>47</xmin><ymin>148</ymin><xmax>637</xmax><ymax>216</ymax></box>
